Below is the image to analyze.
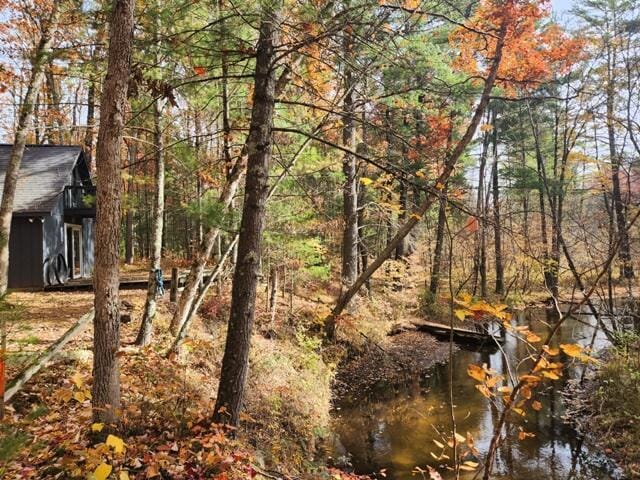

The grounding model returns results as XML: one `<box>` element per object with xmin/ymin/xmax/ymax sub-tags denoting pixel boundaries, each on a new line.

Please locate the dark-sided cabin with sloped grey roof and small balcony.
<box><xmin>0</xmin><ymin>145</ymin><xmax>96</xmax><ymax>289</ymax></box>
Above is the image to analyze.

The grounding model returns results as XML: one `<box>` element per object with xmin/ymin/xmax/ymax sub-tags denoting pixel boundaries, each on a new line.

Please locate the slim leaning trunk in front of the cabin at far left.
<box><xmin>0</xmin><ymin>2</ymin><xmax>60</xmax><ymax>297</ymax></box>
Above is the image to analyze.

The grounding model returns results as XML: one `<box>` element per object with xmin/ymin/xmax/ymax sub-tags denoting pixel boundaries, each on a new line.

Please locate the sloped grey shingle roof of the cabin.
<box><xmin>0</xmin><ymin>144</ymin><xmax>82</xmax><ymax>214</ymax></box>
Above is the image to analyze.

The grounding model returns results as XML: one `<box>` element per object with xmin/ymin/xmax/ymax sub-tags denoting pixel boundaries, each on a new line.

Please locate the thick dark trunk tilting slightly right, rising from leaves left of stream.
<box><xmin>213</xmin><ymin>4</ymin><xmax>279</xmax><ymax>426</ymax></box>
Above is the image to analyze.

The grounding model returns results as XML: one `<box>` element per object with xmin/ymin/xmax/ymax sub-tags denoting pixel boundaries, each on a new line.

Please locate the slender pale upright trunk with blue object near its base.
<box><xmin>136</xmin><ymin>100</ymin><xmax>164</xmax><ymax>346</ymax></box>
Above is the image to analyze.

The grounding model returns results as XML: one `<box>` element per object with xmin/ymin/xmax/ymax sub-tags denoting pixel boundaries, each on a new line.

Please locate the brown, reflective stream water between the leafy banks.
<box><xmin>333</xmin><ymin>308</ymin><xmax>620</xmax><ymax>480</ymax></box>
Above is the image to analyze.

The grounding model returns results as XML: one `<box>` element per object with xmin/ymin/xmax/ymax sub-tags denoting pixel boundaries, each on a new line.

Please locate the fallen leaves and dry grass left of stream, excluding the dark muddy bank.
<box><xmin>0</xmin><ymin>291</ymin><xmax>370</xmax><ymax>480</ymax></box>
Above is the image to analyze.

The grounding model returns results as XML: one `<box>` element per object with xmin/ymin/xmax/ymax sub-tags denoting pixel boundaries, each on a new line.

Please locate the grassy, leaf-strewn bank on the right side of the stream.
<box><xmin>566</xmin><ymin>335</ymin><xmax>640</xmax><ymax>479</ymax></box>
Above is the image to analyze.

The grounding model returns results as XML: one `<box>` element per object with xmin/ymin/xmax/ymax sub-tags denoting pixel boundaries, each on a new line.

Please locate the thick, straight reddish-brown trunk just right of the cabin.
<box><xmin>92</xmin><ymin>0</ymin><xmax>135</xmax><ymax>423</ymax></box>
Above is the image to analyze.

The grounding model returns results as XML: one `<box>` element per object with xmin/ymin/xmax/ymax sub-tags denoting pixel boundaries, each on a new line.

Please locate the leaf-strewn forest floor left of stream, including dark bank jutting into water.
<box><xmin>0</xmin><ymin>251</ymin><xmax>448</xmax><ymax>480</ymax></box>
